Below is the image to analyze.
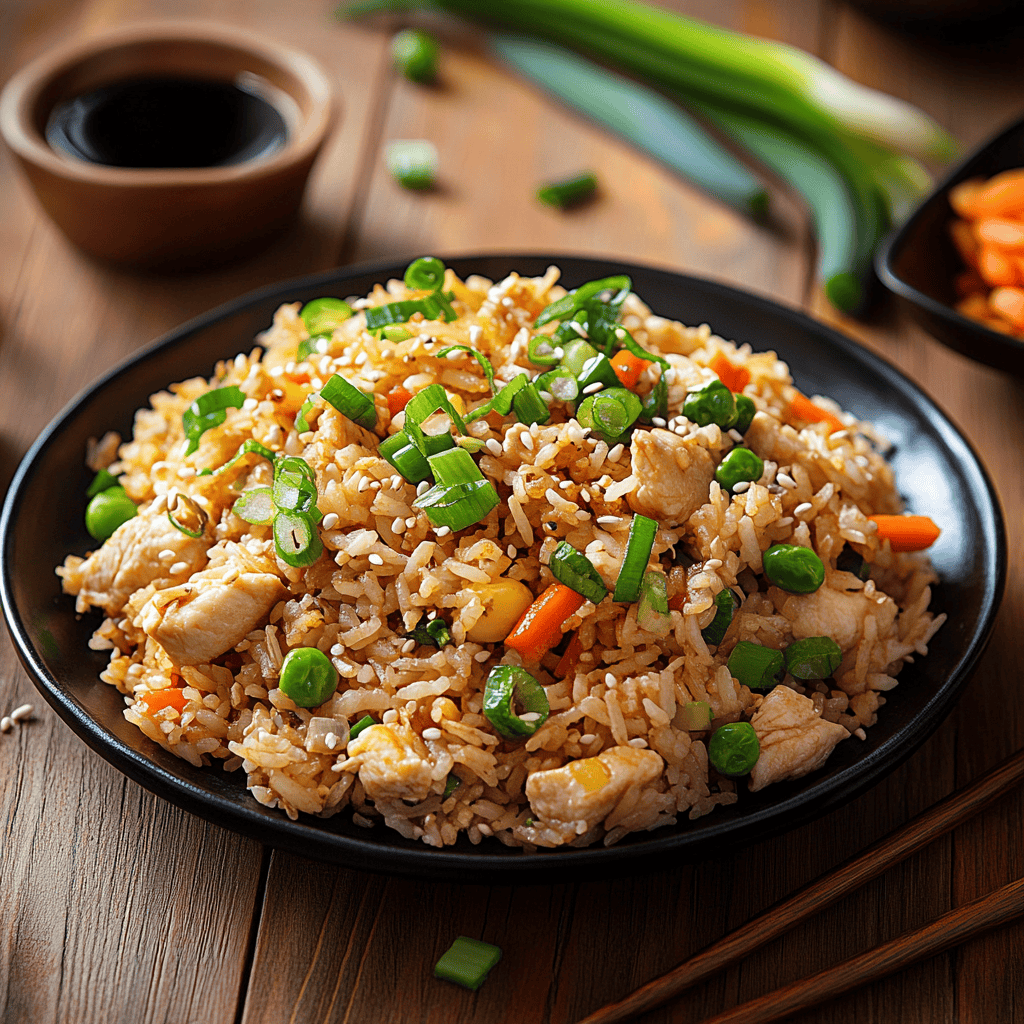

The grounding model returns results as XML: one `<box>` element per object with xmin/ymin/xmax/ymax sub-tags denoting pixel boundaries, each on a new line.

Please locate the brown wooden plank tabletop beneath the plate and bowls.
<box><xmin>0</xmin><ymin>0</ymin><xmax>1024</xmax><ymax>1024</ymax></box>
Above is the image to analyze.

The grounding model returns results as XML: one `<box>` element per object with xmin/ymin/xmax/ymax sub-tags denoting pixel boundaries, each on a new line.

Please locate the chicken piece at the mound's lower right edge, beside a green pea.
<box><xmin>751</xmin><ymin>686</ymin><xmax>849</xmax><ymax>792</ymax></box>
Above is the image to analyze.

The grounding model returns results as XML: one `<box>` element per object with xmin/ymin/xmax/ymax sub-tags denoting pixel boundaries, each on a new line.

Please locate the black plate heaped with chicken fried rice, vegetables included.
<box><xmin>2</xmin><ymin>255</ymin><xmax>1006</xmax><ymax>881</ymax></box>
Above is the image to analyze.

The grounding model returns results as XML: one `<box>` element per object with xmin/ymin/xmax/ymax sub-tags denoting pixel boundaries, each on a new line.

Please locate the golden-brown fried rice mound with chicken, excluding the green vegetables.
<box><xmin>57</xmin><ymin>267</ymin><xmax>945</xmax><ymax>851</ymax></box>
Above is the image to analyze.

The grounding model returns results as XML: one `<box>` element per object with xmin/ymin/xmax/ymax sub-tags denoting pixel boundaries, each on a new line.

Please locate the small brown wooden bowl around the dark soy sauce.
<box><xmin>0</xmin><ymin>23</ymin><xmax>334</xmax><ymax>269</ymax></box>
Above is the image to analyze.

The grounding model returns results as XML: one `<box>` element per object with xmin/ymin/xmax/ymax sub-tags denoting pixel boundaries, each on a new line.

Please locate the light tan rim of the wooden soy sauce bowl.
<box><xmin>0</xmin><ymin>19</ymin><xmax>337</xmax><ymax>188</ymax></box>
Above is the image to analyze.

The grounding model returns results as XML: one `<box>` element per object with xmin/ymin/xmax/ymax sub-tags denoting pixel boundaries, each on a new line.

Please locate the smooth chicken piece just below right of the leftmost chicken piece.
<box><xmin>136</xmin><ymin>564</ymin><xmax>288</xmax><ymax>666</ymax></box>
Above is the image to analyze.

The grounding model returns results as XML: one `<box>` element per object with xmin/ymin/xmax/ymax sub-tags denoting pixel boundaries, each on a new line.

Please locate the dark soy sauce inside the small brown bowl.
<box><xmin>46</xmin><ymin>78</ymin><xmax>288</xmax><ymax>168</ymax></box>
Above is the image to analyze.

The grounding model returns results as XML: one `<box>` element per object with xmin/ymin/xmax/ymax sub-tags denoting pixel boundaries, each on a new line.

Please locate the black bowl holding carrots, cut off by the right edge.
<box><xmin>876</xmin><ymin>114</ymin><xmax>1024</xmax><ymax>374</ymax></box>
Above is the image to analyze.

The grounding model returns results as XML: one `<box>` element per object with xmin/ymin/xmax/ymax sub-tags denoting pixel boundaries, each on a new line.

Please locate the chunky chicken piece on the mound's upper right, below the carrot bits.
<box><xmin>627</xmin><ymin>430</ymin><xmax>715</xmax><ymax>527</ymax></box>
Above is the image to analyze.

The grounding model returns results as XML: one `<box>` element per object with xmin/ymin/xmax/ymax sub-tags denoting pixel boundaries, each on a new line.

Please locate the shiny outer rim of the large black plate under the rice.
<box><xmin>0</xmin><ymin>251</ymin><xmax>1008</xmax><ymax>884</ymax></box>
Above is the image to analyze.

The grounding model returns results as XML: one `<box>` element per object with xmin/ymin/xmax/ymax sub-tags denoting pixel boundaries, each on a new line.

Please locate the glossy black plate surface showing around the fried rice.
<box><xmin>0</xmin><ymin>256</ymin><xmax>1006</xmax><ymax>882</ymax></box>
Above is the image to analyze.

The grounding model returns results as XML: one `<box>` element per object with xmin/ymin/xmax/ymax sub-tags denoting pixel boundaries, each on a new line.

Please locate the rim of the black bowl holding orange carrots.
<box><xmin>874</xmin><ymin>117</ymin><xmax>1024</xmax><ymax>361</ymax></box>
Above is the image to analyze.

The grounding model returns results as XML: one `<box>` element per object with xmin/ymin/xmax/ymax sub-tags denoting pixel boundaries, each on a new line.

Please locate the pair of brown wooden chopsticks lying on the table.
<box><xmin>578</xmin><ymin>751</ymin><xmax>1024</xmax><ymax>1024</ymax></box>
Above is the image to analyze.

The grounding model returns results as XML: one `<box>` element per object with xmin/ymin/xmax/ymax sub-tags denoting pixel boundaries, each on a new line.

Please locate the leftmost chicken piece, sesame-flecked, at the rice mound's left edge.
<box><xmin>65</xmin><ymin>512</ymin><xmax>213</xmax><ymax>615</ymax></box>
